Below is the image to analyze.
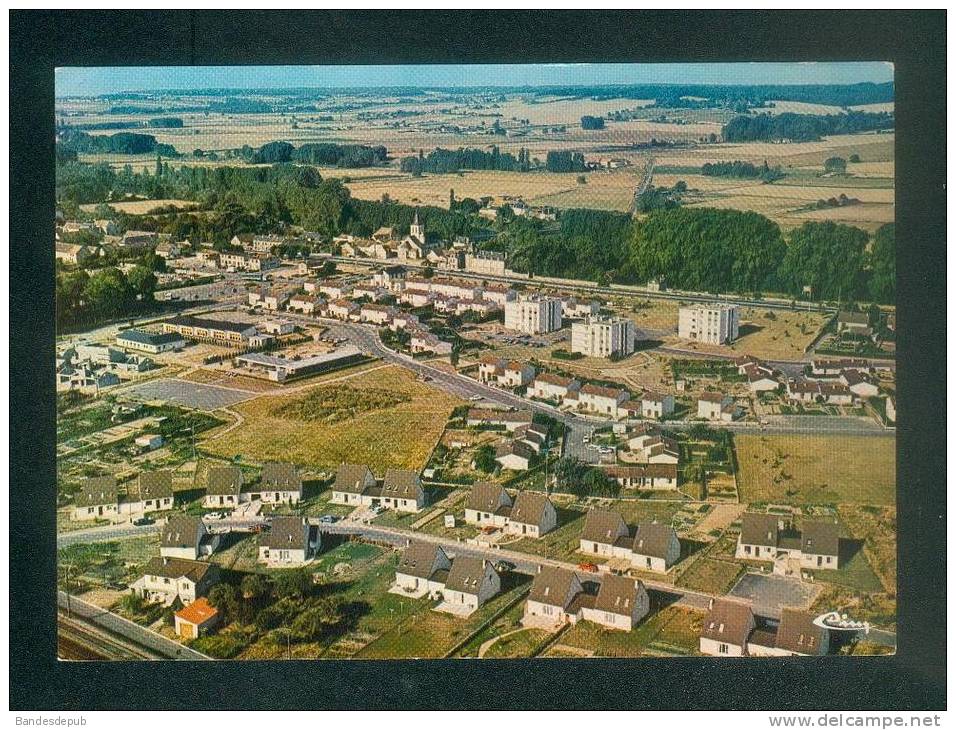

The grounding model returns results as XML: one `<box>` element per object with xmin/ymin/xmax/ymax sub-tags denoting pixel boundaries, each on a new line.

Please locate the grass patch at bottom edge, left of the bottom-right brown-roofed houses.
<box><xmin>555</xmin><ymin>606</ymin><xmax>703</xmax><ymax>657</ymax></box>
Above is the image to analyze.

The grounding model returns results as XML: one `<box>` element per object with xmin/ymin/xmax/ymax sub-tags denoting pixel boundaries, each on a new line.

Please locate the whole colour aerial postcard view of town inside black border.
<box><xmin>56</xmin><ymin>62</ymin><xmax>902</xmax><ymax>666</ymax></box>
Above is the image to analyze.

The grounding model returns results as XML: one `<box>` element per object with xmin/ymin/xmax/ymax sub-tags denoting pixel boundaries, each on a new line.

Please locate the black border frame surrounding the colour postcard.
<box><xmin>9</xmin><ymin>10</ymin><xmax>946</xmax><ymax>711</ymax></box>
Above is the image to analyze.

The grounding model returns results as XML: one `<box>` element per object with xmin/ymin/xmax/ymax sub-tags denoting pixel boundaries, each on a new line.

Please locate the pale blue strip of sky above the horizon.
<box><xmin>56</xmin><ymin>61</ymin><xmax>893</xmax><ymax>96</ymax></box>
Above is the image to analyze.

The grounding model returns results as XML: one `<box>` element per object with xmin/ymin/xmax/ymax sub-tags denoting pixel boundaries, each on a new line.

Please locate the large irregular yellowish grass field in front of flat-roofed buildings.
<box><xmin>202</xmin><ymin>367</ymin><xmax>460</xmax><ymax>473</ymax></box>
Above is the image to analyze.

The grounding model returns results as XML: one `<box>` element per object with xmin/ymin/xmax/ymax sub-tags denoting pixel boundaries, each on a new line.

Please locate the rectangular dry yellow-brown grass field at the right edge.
<box><xmin>736</xmin><ymin>435</ymin><xmax>896</xmax><ymax>505</ymax></box>
